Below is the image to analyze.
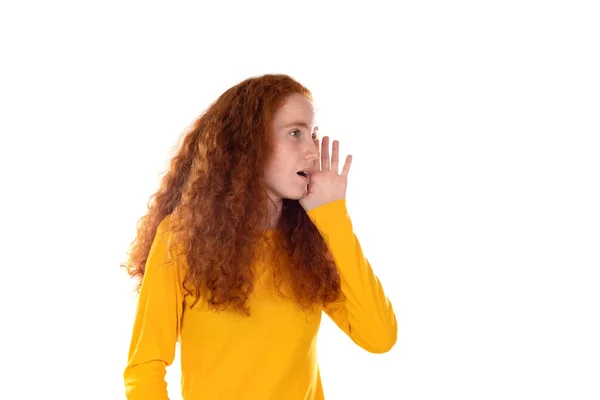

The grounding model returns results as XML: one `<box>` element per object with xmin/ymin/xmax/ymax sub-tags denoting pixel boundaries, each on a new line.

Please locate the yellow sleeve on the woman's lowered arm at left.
<box><xmin>124</xmin><ymin>217</ymin><xmax>183</xmax><ymax>400</ymax></box>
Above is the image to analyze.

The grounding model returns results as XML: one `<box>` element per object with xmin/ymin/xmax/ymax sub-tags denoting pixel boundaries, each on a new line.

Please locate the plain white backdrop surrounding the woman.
<box><xmin>0</xmin><ymin>1</ymin><xmax>600</xmax><ymax>400</ymax></box>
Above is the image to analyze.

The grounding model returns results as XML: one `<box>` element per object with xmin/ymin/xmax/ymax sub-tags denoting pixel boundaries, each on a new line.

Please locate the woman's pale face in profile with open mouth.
<box><xmin>265</xmin><ymin>94</ymin><xmax>319</xmax><ymax>203</ymax></box>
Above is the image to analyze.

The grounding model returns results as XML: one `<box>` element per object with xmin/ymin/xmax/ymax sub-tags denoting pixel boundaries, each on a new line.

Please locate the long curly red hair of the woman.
<box><xmin>121</xmin><ymin>74</ymin><xmax>341</xmax><ymax>315</ymax></box>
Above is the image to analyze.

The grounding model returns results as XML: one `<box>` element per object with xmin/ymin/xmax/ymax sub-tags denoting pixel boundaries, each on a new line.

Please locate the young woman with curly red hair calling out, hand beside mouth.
<box><xmin>123</xmin><ymin>75</ymin><xmax>397</xmax><ymax>400</ymax></box>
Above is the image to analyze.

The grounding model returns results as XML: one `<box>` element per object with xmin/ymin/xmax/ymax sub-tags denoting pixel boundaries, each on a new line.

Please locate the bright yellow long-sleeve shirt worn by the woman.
<box><xmin>124</xmin><ymin>200</ymin><xmax>397</xmax><ymax>400</ymax></box>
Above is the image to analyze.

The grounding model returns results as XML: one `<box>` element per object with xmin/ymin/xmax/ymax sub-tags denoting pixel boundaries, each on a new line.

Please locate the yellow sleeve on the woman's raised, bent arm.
<box><xmin>307</xmin><ymin>200</ymin><xmax>398</xmax><ymax>353</ymax></box>
